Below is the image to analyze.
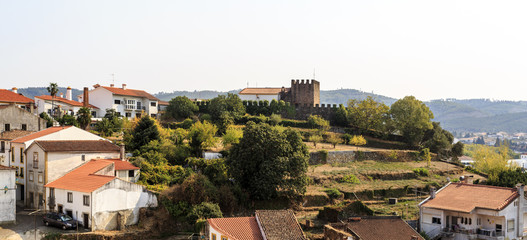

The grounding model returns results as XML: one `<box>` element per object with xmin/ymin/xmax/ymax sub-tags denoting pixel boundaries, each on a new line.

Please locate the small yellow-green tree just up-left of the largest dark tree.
<box><xmin>188</xmin><ymin>121</ymin><xmax>218</xmax><ymax>157</ymax></box>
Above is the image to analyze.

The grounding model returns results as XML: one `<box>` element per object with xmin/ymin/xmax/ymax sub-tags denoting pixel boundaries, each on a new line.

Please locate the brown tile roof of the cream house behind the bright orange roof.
<box><xmin>34</xmin><ymin>140</ymin><xmax>120</xmax><ymax>152</ymax></box>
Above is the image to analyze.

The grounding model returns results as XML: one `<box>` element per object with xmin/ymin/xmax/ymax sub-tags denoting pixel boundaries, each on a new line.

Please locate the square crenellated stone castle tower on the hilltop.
<box><xmin>289</xmin><ymin>79</ymin><xmax>320</xmax><ymax>106</ymax></box>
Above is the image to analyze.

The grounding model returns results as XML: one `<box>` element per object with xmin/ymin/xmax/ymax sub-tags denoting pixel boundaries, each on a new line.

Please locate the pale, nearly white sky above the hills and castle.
<box><xmin>0</xmin><ymin>0</ymin><xmax>527</xmax><ymax>100</ymax></box>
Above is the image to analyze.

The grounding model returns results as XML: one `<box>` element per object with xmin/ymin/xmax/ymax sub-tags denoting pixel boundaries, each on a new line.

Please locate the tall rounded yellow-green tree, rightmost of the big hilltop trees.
<box><xmin>390</xmin><ymin>96</ymin><xmax>434</xmax><ymax>146</ymax></box>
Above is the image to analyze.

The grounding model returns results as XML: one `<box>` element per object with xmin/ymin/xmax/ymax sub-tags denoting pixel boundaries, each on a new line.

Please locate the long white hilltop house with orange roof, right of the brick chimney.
<box><xmin>79</xmin><ymin>84</ymin><xmax>159</xmax><ymax>118</ymax></box>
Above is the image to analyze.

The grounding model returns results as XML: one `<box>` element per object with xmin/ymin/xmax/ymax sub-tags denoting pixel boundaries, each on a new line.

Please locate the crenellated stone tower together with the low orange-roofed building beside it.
<box><xmin>238</xmin><ymin>79</ymin><xmax>320</xmax><ymax>107</ymax></box>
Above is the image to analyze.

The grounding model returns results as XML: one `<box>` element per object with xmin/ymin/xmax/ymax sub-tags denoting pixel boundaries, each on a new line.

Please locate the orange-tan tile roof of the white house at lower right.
<box><xmin>422</xmin><ymin>183</ymin><xmax>519</xmax><ymax>213</ymax></box>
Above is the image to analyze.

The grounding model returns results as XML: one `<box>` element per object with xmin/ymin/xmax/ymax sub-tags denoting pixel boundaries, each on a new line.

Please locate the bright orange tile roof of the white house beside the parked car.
<box><xmin>45</xmin><ymin>159</ymin><xmax>115</xmax><ymax>193</ymax></box>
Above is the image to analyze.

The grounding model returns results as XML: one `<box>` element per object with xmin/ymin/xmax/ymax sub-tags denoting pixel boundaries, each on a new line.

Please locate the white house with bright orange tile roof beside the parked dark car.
<box><xmin>45</xmin><ymin>159</ymin><xmax>157</xmax><ymax>231</ymax></box>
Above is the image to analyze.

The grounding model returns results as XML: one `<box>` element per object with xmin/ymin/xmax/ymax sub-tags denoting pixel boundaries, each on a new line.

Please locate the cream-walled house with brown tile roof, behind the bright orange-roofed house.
<box><xmin>24</xmin><ymin>140</ymin><xmax>121</xmax><ymax>210</ymax></box>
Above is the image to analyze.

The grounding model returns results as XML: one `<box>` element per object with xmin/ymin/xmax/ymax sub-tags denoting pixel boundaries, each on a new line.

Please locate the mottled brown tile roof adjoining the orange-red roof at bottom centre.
<box><xmin>256</xmin><ymin>210</ymin><xmax>307</xmax><ymax>240</ymax></box>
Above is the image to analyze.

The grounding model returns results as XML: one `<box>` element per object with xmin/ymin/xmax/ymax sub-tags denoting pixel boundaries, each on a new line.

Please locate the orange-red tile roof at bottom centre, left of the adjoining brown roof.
<box><xmin>207</xmin><ymin>217</ymin><xmax>263</xmax><ymax>240</ymax></box>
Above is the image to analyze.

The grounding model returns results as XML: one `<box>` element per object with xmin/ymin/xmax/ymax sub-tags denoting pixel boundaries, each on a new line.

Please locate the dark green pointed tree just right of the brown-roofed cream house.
<box><xmin>130</xmin><ymin>115</ymin><xmax>161</xmax><ymax>149</ymax></box>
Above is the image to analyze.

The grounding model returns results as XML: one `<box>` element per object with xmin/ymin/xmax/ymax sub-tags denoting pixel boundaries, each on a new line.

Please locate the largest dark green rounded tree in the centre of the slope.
<box><xmin>227</xmin><ymin>122</ymin><xmax>309</xmax><ymax>200</ymax></box>
